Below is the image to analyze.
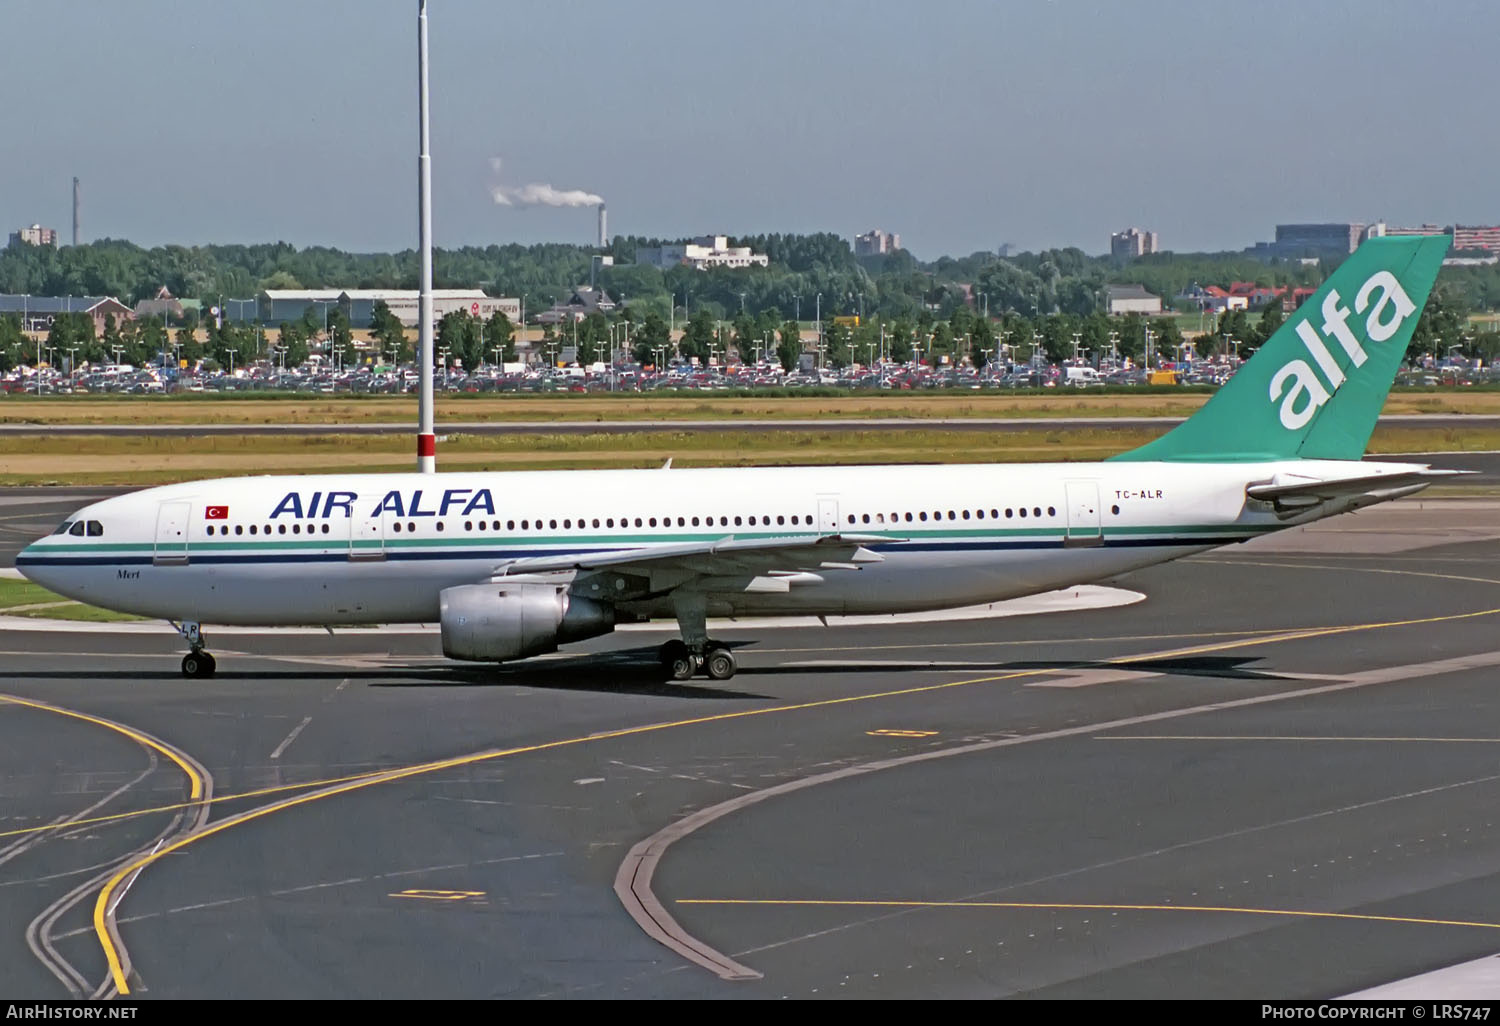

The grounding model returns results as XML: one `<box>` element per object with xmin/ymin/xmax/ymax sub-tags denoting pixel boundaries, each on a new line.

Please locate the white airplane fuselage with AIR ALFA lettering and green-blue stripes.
<box><xmin>17</xmin><ymin>461</ymin><xmax>1410</xmax><ymax>626</ymax></box>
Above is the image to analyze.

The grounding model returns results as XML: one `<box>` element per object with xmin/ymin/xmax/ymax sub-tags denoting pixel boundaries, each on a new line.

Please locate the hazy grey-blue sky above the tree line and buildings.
<box><xmin>0</xmin><ymin>0</ymin><xmax>1500</xmax><ymax>260</ymax></box>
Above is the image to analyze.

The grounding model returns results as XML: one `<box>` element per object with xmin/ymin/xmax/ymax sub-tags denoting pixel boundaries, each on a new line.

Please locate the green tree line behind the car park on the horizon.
<box><xmin>0</xmin><ymin>233</ymin><xmax>1500</xmax><ymax>368</ymax></box>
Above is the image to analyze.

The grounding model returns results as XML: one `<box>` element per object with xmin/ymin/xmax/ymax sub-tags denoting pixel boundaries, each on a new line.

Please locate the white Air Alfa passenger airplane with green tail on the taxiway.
<box><xmin>17</xmin><ymin>237</ymin><xmax>1460</xmax><ymax>681</ymax></box>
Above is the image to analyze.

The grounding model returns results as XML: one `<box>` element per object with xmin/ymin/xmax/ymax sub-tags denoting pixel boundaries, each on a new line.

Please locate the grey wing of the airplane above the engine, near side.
<box><xmin>494</xmin><ymin>534</ymin><xmax>902</xmax><ymax>579</ymax></box>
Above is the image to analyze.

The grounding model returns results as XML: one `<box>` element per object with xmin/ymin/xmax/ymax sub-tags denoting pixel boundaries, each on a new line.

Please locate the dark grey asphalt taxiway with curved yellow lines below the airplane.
<box><xmin>0</xmin><ymin>498</ymin><xmax>1500</xmax><ymax>998</ymax></box>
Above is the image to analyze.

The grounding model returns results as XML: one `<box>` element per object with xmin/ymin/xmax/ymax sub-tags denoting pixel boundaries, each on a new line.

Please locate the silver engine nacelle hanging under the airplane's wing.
<box><xmin>438</xmin><ymin>584</ymin><xmax>615</xmax><ymax>663</ymax></box>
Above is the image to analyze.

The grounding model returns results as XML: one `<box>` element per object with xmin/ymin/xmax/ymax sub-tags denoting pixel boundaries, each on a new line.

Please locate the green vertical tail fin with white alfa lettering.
<box><xmin>1113</xmin><ymin>236</ymin><xmax>1449</xmax><ymax>461</ymax></box>
